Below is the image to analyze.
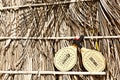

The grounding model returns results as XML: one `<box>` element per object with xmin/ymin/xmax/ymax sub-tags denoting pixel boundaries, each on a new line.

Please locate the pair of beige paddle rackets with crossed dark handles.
<box><xmin>54</xmin><ymin>36</ymin><xmax>105</xmax><ymax>72</ymax></box>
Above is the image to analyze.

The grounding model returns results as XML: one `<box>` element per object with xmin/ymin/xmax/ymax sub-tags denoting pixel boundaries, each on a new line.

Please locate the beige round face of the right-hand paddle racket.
<box><xmin>81</xmin><ymin>48</ymin><xmax>105</xmax><ymax>72</ymax></box>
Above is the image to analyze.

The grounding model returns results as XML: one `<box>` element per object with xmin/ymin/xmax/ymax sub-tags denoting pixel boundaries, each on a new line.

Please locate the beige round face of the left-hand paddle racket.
<box><xmin>54</xmin><ymin>46</ymin><xmax>77</xmax><ymax>71</ymax></box>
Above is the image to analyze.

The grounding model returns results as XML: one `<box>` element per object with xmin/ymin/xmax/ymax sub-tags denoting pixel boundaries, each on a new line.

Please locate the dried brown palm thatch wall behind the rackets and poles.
<box><xmin>0</xmin><ymin>0</ymin><xmax>120</xmax><ymax>80</ymax></box>
